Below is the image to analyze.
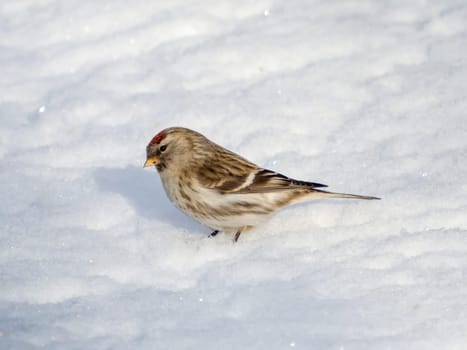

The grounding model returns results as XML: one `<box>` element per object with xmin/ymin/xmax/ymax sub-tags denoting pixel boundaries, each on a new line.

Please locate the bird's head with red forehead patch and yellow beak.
<box><xmin>144</xmin><ymin>127</ymin><xmax>207</xmax><ymax>172</ymax></box>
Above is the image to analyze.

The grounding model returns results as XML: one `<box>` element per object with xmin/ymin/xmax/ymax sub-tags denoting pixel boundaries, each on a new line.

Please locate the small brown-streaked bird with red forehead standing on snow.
<box><xmin>144</xmin><ymin>127</ymin><xmax>380</xmax><ymax>242</ymax></box>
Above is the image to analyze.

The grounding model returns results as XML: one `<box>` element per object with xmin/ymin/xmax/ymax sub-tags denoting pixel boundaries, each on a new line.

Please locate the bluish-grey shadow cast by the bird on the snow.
<box><xmin>94</xmin><ymin>166</ymin><xmax>206</xmax><ymax>234</ymax></box>
